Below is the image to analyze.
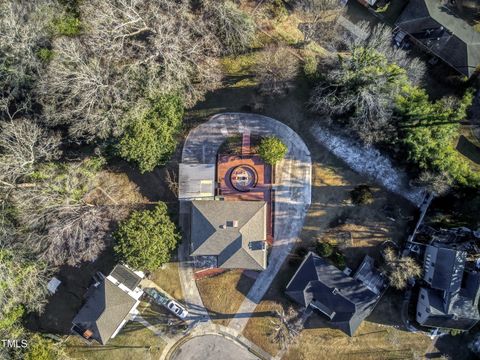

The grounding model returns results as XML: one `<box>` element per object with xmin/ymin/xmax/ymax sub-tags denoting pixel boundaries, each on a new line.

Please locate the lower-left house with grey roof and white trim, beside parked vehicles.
<box><xmin>72</xmin><ymin>265</ymin><xmax>143</xmax><ymax>345</ymax></box>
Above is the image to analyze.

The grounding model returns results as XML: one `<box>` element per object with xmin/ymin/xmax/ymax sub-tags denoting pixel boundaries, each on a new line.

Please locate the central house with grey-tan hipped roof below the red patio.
<box><xmin>191</xmin><ymin>200</ymin><xmax>267</xmax><ymax>270</ymax></box>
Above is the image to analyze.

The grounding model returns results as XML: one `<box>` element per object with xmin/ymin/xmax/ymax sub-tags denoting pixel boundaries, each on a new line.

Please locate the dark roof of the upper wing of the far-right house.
<box><xmin>424</xmin><ymin>245</ymin><xmax>467</xmax><ymax>292</ymax></box>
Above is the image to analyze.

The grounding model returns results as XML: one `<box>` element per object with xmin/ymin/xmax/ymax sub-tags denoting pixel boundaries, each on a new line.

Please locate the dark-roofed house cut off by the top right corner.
<box><xmin>396</xmin><ymin>0</ymin><xmax>480</xmax><ymax>77</ymax></box>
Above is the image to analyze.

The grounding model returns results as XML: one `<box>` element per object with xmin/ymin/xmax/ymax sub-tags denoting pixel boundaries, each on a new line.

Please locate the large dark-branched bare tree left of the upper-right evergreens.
<box><xmin>310</xmin><ymin>47</ymin><xmax>398</xmax><ymax>144</ymax></box>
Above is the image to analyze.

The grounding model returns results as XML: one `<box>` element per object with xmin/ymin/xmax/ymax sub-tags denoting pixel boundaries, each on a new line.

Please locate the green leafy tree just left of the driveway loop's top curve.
<box><xmin>118</xmin><ymin>95</ymin><xmax>183</xmax><ymax>173</ymax></box>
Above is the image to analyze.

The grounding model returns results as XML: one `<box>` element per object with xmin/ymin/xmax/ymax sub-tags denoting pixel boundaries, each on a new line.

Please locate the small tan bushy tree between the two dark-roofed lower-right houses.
<box><xmin>383</xmin><ymin>247</ymin><xmax>422</xmax><ymax>290</ymax></box>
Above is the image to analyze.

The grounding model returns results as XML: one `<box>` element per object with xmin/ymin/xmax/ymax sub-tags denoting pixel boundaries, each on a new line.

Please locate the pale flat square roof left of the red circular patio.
<box><xmin>178</xmin><ymin>163</ymin><xmax>215</xmax><ymax>200</ymax></box>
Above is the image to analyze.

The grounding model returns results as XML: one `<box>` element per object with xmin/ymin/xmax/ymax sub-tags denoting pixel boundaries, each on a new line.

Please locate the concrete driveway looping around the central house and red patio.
<box><xmin>180</xmin><ymin>113</ymin><xmax>312</xmax><ymax>332</ymax></box>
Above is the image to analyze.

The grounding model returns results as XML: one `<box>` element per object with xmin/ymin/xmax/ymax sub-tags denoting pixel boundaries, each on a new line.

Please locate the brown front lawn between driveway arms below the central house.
<box><xmin>197</xmin><ymin>270</ymin><xmax>254</xmax><ymax>326</ymax></box>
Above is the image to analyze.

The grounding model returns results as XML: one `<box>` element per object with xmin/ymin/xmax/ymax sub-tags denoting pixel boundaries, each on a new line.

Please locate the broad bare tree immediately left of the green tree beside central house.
<box><xmin>11</xmin><ymin>160</ymin><xmax>123</xmax><ymax>265</ymax></box>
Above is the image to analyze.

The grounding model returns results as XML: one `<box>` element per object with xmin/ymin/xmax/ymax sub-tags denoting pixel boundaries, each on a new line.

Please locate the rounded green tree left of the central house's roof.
<box><xmin>114</xmin><ymin>202</ymin><xmax>181</xmax><ymax>271</ymax></box>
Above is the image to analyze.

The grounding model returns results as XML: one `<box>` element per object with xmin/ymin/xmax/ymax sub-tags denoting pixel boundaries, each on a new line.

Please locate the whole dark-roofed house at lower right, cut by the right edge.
<box><xmin>416</xmin><ymin>244</ymin><xmax>480</xmax><ymax>330</ymax></box>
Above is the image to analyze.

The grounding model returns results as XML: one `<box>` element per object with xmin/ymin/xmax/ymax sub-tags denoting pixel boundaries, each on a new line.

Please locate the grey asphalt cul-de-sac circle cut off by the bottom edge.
<box><xmin>170</xmin><ymin>335</ymin><xmax>259</xmax><ymax>360</ymax></box>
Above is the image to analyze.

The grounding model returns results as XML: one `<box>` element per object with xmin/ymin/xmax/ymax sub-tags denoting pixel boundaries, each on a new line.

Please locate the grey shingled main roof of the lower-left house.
<box><xmin>72</xmin><ymin>279</ymin><xmax>137</xmax><ymax>345</ymax></box>
